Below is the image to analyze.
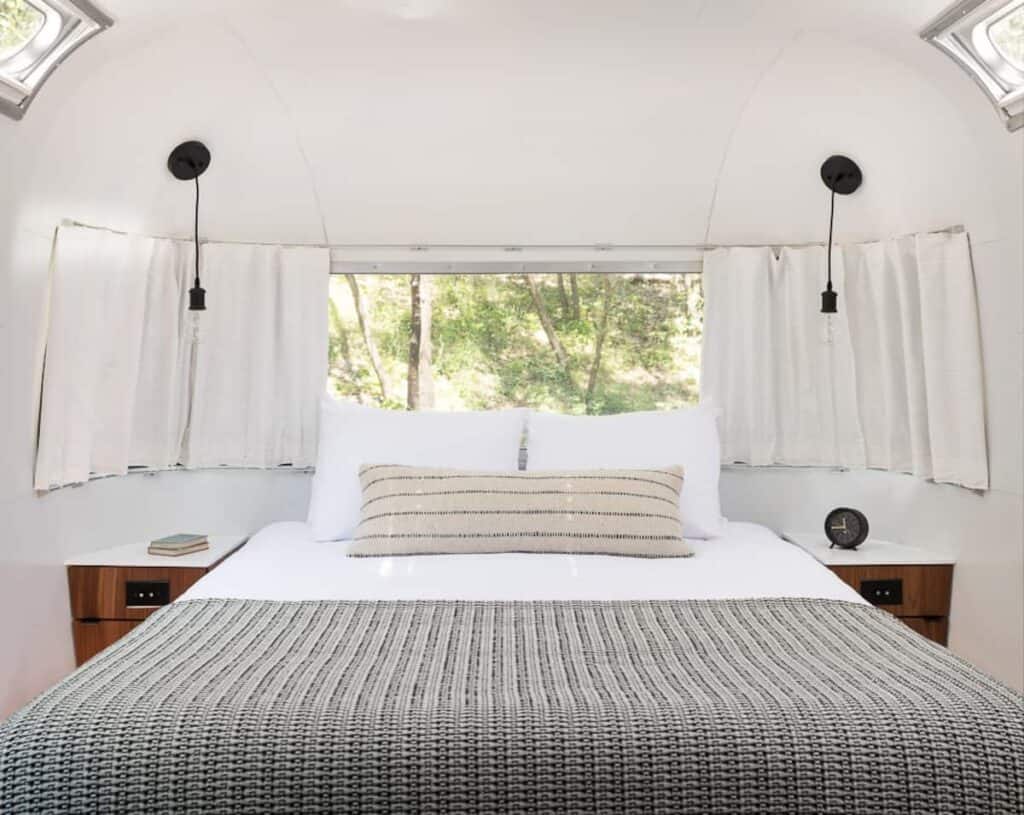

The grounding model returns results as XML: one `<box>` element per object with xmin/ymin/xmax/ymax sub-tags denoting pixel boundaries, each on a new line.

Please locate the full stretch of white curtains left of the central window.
<box><xmin>35</xmin><ymin>226</ymin><xmax>330</xmax><ymax>489</ymax></box>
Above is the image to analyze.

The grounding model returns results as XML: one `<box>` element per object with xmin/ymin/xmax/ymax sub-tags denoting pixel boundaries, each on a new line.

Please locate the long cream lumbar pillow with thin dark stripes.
<box><xmin>349</xmin><ymin>464</ymin><xmax>693</xmax><ymax>557</ymax></box>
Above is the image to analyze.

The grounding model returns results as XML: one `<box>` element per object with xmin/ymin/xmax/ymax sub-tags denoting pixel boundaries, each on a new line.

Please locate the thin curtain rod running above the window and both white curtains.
<box><xmin>61</xmin><ymin>218</ymin><xmax>966</xmax><ymax>255</ymax></box>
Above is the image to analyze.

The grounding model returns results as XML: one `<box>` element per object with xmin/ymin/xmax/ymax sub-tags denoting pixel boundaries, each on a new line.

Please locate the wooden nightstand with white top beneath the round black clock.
<box><xmin>782</xmin><ymin>534</ymin><xmax>955</xmax><ymax>645</ymax></box>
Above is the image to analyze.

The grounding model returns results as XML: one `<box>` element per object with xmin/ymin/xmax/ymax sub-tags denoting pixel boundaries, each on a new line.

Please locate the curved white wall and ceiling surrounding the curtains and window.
<box><xmin>0</xmin><ymin>0</ymin><xmax>1024</xmax><ymax>716</ymax></box>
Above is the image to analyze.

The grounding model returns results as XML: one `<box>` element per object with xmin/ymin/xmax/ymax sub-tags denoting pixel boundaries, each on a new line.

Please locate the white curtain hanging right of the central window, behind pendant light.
<box><xmin>701</xmin><ymin>233</ymin><xmax>988</xmax><ymax>489</ymax></box>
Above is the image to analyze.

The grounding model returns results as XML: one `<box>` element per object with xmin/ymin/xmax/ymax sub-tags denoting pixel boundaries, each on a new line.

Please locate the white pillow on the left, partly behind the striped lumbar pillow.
<box><xmin>308</xmin><ymin>396</ymin><xmax>525</xmax><ymax>541</ymax></box>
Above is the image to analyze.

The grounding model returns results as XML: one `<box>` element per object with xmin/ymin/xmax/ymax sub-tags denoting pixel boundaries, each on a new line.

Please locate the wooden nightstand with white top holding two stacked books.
<box><xmin>65</xmin><ymin>535</ymin><xmax>248</xmax><ymax>664</ymax></box>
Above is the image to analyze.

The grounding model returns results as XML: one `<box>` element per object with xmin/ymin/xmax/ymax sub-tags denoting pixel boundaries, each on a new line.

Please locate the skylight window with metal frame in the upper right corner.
<box><xmin>921</xmin><ymin>0</ymin><xmax>1024</xmax><ymax>130</ymax></box>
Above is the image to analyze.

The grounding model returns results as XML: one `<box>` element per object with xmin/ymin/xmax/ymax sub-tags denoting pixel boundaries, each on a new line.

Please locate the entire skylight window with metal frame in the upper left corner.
<box><xmin>0</xmin><ymin>0</ymin><xmax>112</xmax><ymax>119</ymax></box>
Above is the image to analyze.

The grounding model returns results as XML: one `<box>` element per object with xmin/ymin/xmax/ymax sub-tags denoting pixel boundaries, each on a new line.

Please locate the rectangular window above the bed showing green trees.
<box><xmin>328</xmin><ymin>264</ymin><xmax>703</xmax><ymax>414</ymax></box>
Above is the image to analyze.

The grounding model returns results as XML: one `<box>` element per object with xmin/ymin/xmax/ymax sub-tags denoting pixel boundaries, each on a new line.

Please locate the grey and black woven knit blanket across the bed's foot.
<box><xmin>0</xmin><ymin>600</ymin><xmax>1024</xmax><ymax>815</ymax></box>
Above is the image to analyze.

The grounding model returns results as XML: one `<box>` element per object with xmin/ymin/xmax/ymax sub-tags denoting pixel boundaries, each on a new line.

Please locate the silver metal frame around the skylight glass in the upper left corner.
<box><xmin>0</xmin><ymin>0</ymin><xmax>114</xmax><ymax>121</ymax></box>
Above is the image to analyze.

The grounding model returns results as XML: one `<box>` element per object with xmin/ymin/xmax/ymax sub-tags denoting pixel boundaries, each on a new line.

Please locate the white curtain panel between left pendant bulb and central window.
<box><xmin>183</xmin><ymin>244</ymin><xmax>331</xmax><ymax>467</ymax></box>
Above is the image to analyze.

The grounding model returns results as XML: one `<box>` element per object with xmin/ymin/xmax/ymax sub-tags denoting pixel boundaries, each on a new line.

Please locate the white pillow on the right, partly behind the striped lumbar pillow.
<box><xmin>526</xmin><ymin>408</ymin><xmax>725</xmax><ymax>538</ymax></box>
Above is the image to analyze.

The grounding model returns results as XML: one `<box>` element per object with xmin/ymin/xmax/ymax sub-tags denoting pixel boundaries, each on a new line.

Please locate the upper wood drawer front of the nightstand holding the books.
<box><xmin>68</xmin><ymin>566</ymin><xmax>208</xmax><ymax>619</ymax></box>
